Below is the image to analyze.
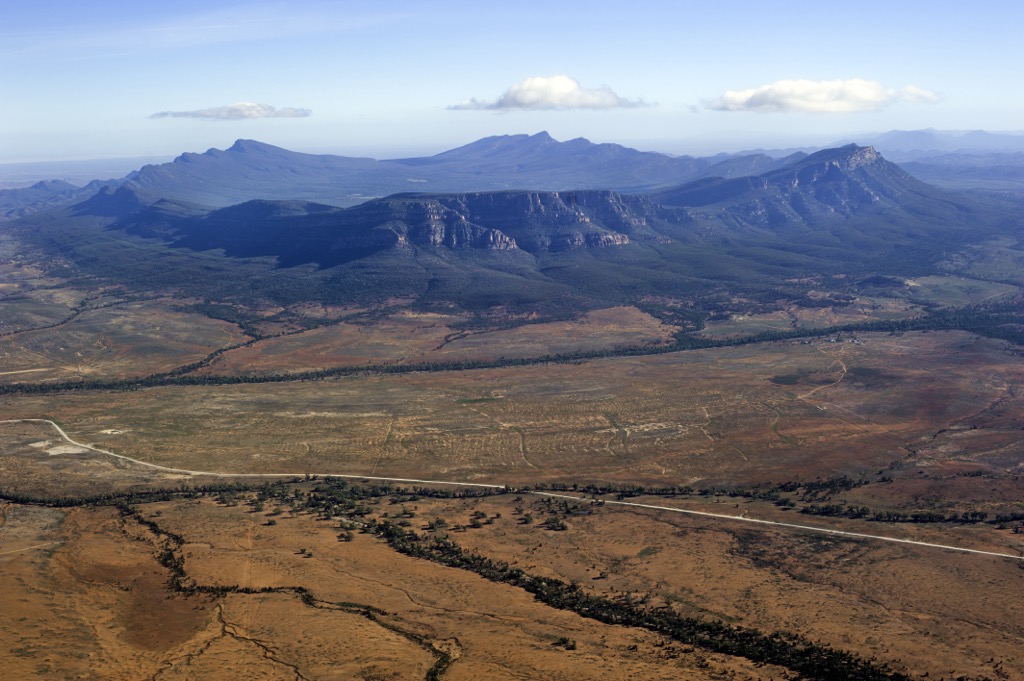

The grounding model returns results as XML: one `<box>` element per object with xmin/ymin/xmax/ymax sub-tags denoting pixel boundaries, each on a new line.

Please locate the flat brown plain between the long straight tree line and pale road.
<box><xmin>0</xmin><ymin>332</ymin><xmax>1024</xmax><ymax>484</ymax></box>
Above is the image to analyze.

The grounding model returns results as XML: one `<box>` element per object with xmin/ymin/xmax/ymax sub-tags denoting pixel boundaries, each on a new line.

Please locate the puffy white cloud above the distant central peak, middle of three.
<box><xmin>449</xmin><ymin>76</ymin><xmax>646</xmax><ymax>110</ymax></box>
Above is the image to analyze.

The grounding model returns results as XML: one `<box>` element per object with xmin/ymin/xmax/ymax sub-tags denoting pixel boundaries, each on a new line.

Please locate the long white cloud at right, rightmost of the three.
<box><xmin>705</xmin><ymin>78</ymin><xmax>939</xmax><ymax>114</ymax></box>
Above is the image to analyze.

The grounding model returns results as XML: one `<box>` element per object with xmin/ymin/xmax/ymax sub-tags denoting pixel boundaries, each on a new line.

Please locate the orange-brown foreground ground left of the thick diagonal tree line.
<box><xmin>0</xmin><ymin>493</ymin><xmax>780</xmax><ymax>681</ymax></box>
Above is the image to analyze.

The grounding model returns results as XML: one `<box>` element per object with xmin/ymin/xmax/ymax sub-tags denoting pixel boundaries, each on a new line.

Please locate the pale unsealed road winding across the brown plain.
<box><xmin>0</xmin><ymin>419</ymin><xmax>1024</xmax><ymax>561</ymax></box>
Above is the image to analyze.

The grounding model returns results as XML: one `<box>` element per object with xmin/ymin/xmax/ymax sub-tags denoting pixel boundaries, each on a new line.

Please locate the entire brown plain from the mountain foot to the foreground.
<box><xmin>0</xmin><ymin>262</ymin><xmax>1024</xmax><ymax>680</ymax></box>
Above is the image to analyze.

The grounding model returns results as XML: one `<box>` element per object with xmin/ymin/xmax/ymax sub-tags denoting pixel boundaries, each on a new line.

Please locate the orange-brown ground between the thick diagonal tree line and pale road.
<box><xmin>409</xmin><ymin>496</ymin><xmax>1024</xmax><ymax>679</ymax></box>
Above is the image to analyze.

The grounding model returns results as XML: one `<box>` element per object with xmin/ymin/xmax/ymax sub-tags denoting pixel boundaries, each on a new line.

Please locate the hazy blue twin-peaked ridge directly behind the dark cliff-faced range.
<box><xmin>119</xmin><ymin>132</ymin><xmax>790</xmax><ymax>207</ymax></box>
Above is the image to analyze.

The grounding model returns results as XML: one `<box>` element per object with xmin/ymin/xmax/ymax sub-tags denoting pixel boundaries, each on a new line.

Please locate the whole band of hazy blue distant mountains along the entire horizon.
<box><xmin>8</xmin><ymin>130</ymin><xmax>1024</xmax><ymax>219</ymax></box>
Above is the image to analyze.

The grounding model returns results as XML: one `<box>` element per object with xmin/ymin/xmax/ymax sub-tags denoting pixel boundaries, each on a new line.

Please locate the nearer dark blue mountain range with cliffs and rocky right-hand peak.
<box><xmin>12</xmin><ymin>140</ymin><xmax>998</xmax><ymax>309</ymax></box>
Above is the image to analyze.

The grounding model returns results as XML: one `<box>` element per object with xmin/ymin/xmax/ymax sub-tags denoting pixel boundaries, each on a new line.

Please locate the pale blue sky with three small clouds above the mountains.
<box><xmin>0</xmin><ymin>0</ymin><xmax>1024</xmax><ymax>163</ymax></box>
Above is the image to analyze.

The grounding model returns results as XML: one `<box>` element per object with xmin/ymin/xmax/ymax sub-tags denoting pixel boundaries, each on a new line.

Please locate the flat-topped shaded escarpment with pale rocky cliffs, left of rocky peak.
<box><xmin>142</xmin><ymin>189</ymin><xmax>655</xmax><ymax>267</ymax></box>
